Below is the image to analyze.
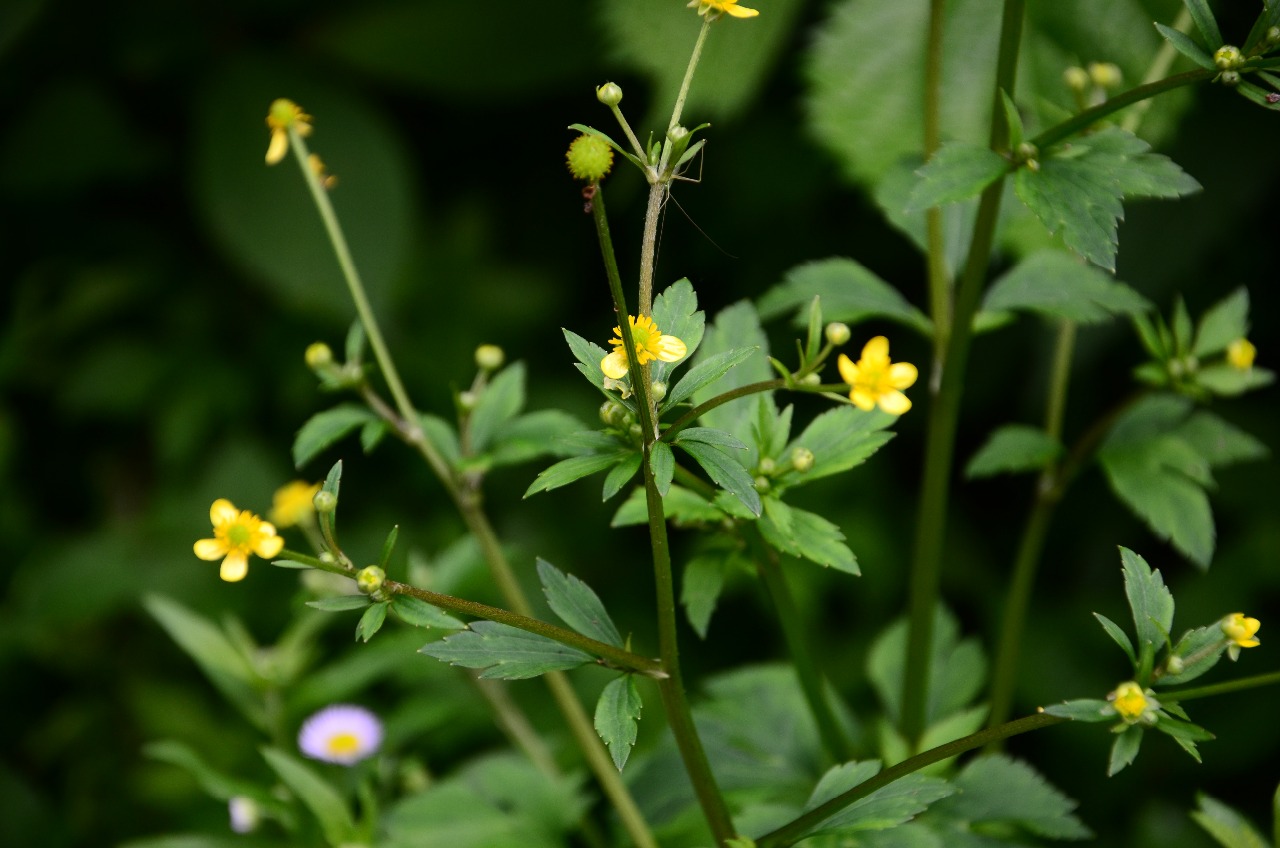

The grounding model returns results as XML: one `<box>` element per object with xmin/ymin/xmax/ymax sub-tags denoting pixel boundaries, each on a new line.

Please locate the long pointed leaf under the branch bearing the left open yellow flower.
<box><xmin>419</xmin><ymin>621</ymin><xmax>595</xmax><ymax>680</ymax></box>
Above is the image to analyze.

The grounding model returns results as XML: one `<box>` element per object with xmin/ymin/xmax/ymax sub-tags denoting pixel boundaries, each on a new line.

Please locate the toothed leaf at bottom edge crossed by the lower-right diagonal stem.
<box><xmin>805</xmin><ymin>761</ymin><xmax>955</xmax><ymax>836</ymax></box>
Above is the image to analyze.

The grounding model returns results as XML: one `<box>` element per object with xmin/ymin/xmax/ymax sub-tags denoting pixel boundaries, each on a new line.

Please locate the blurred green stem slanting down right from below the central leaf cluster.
<box><xmin>741</xmin><ymin>521</ymin><xmax>854</xmax><ymax>762</ymax></box>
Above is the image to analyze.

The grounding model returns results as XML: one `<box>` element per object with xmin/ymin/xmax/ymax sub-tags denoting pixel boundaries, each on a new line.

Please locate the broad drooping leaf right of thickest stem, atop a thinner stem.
<box><xmin>982</xmin><ymin>250</ymin><xmax>1152</xmax><ymax>324</ymax></box>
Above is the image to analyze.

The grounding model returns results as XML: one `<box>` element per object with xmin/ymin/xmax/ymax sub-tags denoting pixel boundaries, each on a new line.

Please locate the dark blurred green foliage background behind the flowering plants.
<box><xmin>0</xmin><ymin>0</ymin><xmax>1280</xmax><ymax>847</ymax></box>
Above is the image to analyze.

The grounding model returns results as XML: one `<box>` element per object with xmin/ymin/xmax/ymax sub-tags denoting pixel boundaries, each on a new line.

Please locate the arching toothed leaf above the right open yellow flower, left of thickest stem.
<box><xmin>759</xmin><ymin>257</ymin><xmax>933</xmax><ymax>336</ymax></box>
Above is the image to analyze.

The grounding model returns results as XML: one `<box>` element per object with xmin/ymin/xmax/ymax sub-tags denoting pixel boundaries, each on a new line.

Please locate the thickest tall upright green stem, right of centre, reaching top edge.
<box><xmin>902</xmin><ymin>0</ymin><xmax>1025</xmax><ymax>744</ymax></box>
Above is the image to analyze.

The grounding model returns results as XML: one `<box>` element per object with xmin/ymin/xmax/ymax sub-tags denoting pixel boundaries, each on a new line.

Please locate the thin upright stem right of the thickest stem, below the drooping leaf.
<box><xmin>987</xmin><ymin>320</ymin><xmax>1075</xmax><ymax>728</ymax></box>
